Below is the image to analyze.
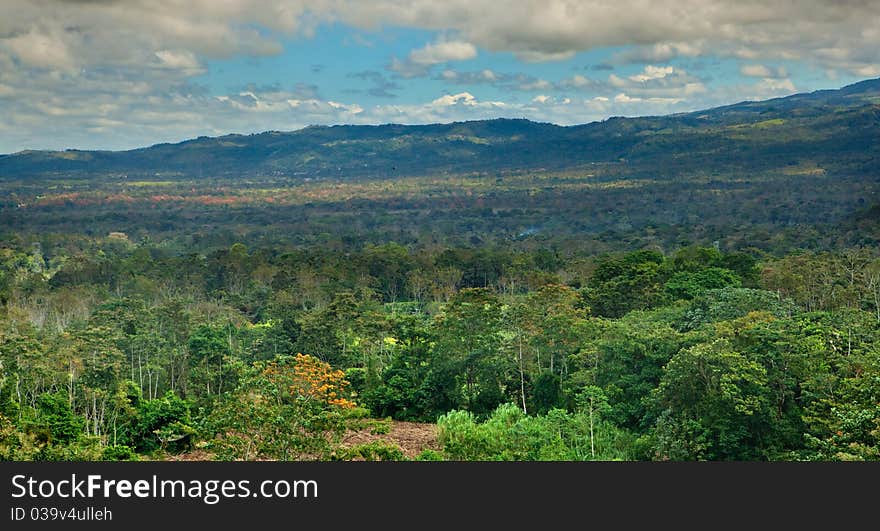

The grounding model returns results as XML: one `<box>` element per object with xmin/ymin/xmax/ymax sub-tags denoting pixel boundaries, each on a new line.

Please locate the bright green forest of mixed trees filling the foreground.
<box><xmin>0</xmin><ymin>235</ymin><xmax>880</xmax><ymax>460</ymax></box>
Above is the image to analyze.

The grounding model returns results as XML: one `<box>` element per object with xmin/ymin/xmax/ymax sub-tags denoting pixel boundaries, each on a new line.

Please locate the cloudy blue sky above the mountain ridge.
<box><xmin>0</xmin><ymin>0</ymin><xmax>880</xmax><ymax>153</ymax></box>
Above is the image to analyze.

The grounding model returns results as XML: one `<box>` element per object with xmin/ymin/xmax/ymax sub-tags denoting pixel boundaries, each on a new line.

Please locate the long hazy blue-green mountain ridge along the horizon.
<box><xmin>0</xmin><ymin>79</ymin><xmax>880</xmax><ymax>179</ymax></box>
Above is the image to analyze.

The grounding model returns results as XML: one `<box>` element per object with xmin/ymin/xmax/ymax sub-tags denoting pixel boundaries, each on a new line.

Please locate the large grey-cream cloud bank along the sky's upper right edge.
<box><xmin>338</xmin><ymin>0</ymin><xmax>880</xmax><ymax>72</ymax></box>
